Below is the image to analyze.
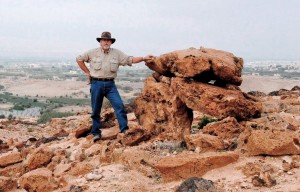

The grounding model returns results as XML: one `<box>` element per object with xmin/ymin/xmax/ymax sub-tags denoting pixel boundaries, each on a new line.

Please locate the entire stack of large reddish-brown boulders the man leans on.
<box><xmin>132</xmin><ymin>48</ymin><xmax>262</xmax><ymax>148</ymax></box>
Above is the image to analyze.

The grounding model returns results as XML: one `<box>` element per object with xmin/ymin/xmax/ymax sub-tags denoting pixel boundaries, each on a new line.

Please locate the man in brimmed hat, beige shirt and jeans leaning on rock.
<box><xmin>76</xmin><ymin>32</ymin><xmax>153</xmax><ymax>142</ymax></box>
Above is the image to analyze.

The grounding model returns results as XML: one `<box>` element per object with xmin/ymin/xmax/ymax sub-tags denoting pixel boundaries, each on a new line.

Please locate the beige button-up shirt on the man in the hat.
<box><xmin>76</xmin><ymin>47</ymin><xmax>133</xmax><ymax>78</ymax></box>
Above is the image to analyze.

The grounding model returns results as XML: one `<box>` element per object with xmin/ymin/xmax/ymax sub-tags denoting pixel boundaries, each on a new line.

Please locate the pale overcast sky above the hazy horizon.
<box><xmin>0</xmin><ymin>0</ymin><xmax>300</xmax><ymax>60</ymax></box>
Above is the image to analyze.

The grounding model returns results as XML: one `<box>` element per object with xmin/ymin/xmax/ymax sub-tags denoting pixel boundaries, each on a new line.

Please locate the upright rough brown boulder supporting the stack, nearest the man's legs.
<box><xmin>135</xmin><ymin>77</ymin><xmax>192</xmax><ymax>140</ymax></box>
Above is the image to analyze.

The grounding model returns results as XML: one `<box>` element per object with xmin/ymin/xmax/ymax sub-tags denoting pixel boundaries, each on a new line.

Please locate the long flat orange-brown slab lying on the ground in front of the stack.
<box><xmin>155</xmin><ymin>152</ymin><xmax>239</xmax><ymax>182</ymax></box>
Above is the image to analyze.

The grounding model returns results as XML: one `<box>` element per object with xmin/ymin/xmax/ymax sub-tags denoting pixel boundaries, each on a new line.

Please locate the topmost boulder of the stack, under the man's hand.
<box><xmin>147</xmin><ymin>47</ymin><xmax>243</xmax><ymax>85</ymax></box>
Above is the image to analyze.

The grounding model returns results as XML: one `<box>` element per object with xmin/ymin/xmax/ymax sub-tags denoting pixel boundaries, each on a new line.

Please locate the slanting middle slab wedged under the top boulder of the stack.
<box><xmin>171</xmin><ymin>78</ymin><xmax>261</xmax><ymax>120</ymax></box>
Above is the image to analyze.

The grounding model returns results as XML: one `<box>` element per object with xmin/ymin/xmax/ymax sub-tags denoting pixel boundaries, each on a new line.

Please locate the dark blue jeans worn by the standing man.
<box><xmin>90</xmin><ymin>81</ymin><xmax>128</xmax><ymax>135</ymax></box>
